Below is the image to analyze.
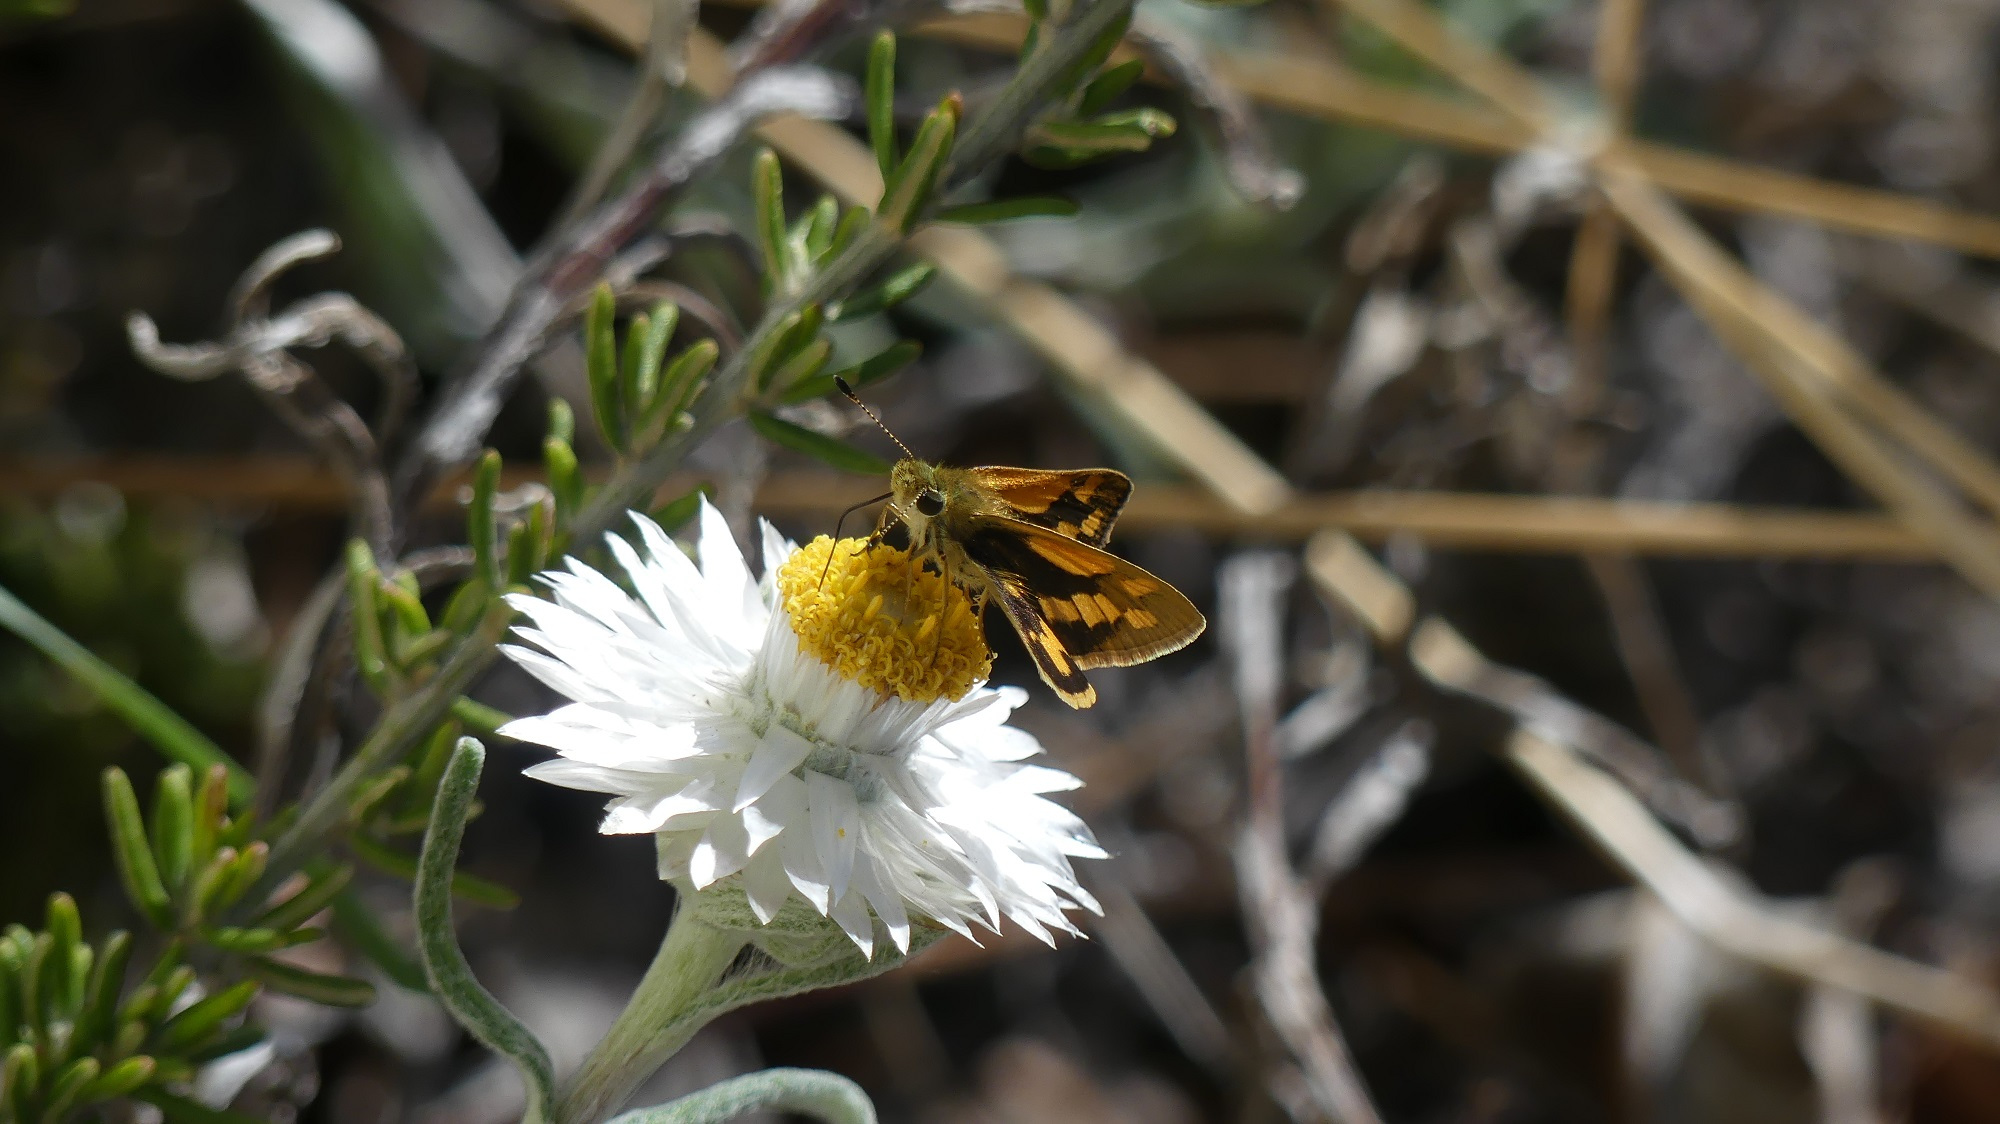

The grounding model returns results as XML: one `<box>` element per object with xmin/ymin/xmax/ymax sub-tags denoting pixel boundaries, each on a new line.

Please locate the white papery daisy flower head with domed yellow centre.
<box><xmin>502</xmin><ymin>500</ymin><xmax>1104</xmax><ymax>956</ymax></box>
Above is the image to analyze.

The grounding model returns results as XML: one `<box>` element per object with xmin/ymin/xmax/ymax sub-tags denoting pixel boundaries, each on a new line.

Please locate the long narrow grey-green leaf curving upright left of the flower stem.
<box><xmin>416</xmin><ymin>738</ymin><xmax>556</xmax><ymax>1124</ymax></box>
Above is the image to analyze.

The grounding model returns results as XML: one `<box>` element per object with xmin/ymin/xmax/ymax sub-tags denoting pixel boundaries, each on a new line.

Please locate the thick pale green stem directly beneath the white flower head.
<box><xmin>556</xmin><ymin>904</ymin><xmax>746</xmax><ymax>1124</ymax></box>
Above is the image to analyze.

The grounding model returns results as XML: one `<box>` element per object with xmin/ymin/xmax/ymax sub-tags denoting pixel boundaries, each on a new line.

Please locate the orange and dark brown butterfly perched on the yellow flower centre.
<box><xmin>840</xmin><ymin>384</ymin><xmax>1208</xmax><ymax>708</ymax></box>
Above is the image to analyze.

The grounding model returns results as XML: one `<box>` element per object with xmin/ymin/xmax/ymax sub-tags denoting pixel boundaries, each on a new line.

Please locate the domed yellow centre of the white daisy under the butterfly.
<box><xmin>778</xmin><ymin>534</ymin><xmax>994</xmax><ymax>702</ymax></box>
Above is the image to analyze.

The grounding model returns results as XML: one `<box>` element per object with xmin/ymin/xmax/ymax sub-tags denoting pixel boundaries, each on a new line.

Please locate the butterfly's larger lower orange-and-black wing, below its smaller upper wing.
<box><xmin>958</xmin><ymin>516</ymin><xmax>1206</xmax><ymax>706</ymax></box>
